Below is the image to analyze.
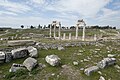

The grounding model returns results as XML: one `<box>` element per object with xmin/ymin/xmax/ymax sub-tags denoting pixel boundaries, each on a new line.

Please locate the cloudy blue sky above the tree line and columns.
<box><xmin>0</xmin><ymin>0</ymin><xmax>120</xmax><ymax>28</ymax></box>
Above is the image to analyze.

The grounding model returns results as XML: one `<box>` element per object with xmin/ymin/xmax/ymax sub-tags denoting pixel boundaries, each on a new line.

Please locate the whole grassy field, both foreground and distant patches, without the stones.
<box><xmin>0</xmin><ymin>29</ymin><xmax>120</xmax><ymax>80</ymax></box>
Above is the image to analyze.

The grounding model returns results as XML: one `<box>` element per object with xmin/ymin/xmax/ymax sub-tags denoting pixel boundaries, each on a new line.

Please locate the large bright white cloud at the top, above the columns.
<box><xmin>47</xmin><ymin>0</ymin><xmax>111</xmax><ymax>16</ymax></box>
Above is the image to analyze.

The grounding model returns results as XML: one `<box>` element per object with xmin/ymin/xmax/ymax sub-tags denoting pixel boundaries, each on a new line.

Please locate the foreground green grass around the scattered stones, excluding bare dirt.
<box><xmin>0</xmin><ymin>42</ymin><xmax>120</xmax><ymax>80</ymax></box>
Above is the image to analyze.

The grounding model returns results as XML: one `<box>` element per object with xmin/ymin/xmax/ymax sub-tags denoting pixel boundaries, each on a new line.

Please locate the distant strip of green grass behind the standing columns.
<box><xmin>0</xmin><ymin>29</ymin><xmax>117</xmax><ymax>38</ymax></box>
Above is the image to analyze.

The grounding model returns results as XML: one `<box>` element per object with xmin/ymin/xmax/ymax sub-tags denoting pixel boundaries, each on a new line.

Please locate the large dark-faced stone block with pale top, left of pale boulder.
<box><xmin>11</xmin><ymin>48</ymin><xmax>29</xmax><ymax>59</ymax></box>
